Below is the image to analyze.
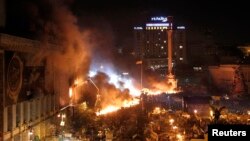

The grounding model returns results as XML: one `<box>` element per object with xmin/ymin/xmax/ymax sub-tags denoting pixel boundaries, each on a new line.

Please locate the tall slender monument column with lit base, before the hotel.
<box><xmin>167</xmin><ymin>27</ymin><xmax>177</xmax><ymax>92</ymax></box>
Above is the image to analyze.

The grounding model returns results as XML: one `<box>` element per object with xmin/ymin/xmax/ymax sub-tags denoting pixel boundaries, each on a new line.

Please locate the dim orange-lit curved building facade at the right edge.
<box><xmin>208</xmin><ymin>64</ymin><xmax>250</xmax><ymax>96</ymax></box>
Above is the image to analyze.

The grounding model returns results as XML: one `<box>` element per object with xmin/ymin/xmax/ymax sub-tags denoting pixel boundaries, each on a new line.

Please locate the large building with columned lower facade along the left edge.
<box><xmin>0</xmin><ymin>34</ymin><xmax>66</xmax><ymax>141</ymax></box>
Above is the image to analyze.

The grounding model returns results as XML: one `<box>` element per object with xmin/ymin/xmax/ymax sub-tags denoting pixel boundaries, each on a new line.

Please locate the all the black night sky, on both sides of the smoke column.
<box><xmin>4</xmin><ymin>0</ymin><xmax>250</xmax><ymax>45</ymax></box>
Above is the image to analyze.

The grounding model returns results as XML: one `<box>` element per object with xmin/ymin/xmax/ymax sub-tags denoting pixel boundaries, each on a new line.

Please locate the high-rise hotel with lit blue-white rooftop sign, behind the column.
<box><xmin>134</xmin><ymin>16</ymin><xmax>187</xmax><ymax>75</ymax></box>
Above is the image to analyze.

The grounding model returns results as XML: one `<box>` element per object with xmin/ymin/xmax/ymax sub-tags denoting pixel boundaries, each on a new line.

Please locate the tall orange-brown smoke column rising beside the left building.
<box><xmin>25</xmin><ymin>0</ymin><xmax>96</xmax><ymax>105</ymax></box>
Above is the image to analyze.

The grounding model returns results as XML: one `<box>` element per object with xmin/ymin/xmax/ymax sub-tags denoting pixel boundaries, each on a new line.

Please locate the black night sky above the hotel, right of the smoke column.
<box><xmin>72</xmin><ymin>0</ymin><xmax>250</xmax><ymax>44</ymax></box>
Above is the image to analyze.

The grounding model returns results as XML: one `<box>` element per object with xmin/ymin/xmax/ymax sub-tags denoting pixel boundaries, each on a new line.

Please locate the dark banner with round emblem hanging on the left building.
<box><xmin>4</xmin><ymin>51</ymin><xmax>45</xmax><ymax>106</ymax></box>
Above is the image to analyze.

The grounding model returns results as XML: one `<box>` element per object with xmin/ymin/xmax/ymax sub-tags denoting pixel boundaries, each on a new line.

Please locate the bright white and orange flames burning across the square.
<box><xmin>86</xmin><ymin>64</ymin><xmax>178</xmax><ymax>116</ymax></box>
